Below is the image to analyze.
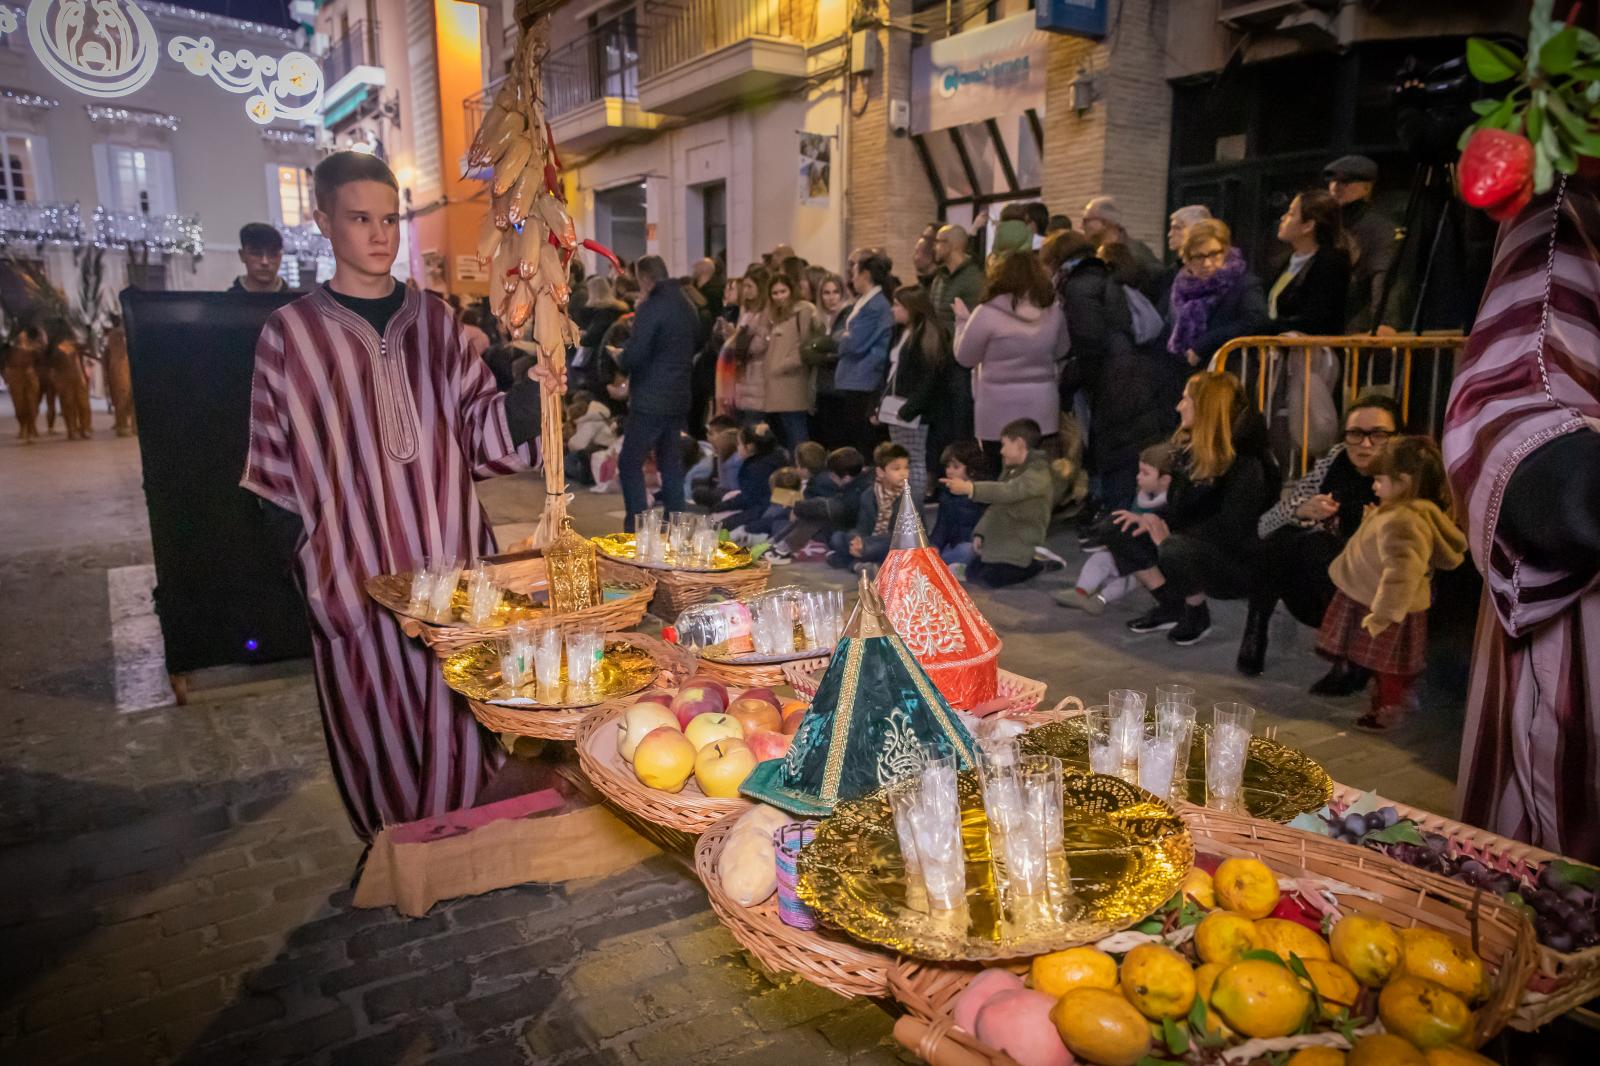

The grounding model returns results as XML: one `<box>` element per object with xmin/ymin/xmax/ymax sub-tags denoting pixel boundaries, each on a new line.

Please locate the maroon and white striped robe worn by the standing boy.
<box><xmin>240</xmin><ymin>281</ymin><xmax>528</xmax><ymax>839</ymax></box>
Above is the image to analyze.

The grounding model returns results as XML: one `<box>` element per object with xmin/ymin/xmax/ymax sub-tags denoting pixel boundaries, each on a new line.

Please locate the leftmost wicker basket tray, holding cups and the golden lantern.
<box><xmin>366</xmin><ymin>559</ymin><xmax>656</xmax><ymax>659</ymax></box>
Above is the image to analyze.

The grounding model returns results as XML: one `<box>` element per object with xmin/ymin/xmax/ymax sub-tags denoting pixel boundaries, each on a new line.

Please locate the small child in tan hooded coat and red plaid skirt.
<box><xmin>1317</xmin><ymin>437</ymin><xmax>1467</xmax><ymax>730</ymax></box>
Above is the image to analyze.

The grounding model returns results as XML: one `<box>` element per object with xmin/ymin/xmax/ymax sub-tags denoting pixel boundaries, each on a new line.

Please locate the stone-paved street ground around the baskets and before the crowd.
<box><xmin>0</xmin><ymin>419</ymin><xmax>1542</xmax><ymax>1066</ymax></box>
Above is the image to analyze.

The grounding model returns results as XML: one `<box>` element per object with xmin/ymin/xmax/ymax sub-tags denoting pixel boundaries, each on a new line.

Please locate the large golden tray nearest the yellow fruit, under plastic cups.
<box><xmin>797</xmin><ymin>770</ymin><xmax>1195</xmax><ymax>962</ymax></box>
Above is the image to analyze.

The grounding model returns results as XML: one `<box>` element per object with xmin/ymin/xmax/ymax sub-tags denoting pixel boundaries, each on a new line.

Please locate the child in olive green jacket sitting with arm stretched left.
<box><xmin>939</xmin><ymin>418</ymin><xmax>1053</xmax><ymax>589</ymax></box>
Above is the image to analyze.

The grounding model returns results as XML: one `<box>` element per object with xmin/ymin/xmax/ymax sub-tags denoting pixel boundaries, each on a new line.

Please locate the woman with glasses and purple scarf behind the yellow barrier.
<box><xmin>1166</xmin><ymin>218</ymin><xmax>1267</xmax><ymax>367</ymax></box>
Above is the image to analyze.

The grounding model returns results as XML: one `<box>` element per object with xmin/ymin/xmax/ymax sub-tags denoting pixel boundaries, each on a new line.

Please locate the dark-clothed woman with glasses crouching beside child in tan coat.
<box><xmin>1237</xmin><ymin>394</ymin><xmax>1403</xmax><ymax>681</ymax></box>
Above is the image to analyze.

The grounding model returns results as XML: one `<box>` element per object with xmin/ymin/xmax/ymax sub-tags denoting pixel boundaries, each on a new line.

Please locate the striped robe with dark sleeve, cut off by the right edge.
<box><xmin>1443</xmin><ymin>176</ymin><xmax>1600</xmax><ymax>863</ymax></box>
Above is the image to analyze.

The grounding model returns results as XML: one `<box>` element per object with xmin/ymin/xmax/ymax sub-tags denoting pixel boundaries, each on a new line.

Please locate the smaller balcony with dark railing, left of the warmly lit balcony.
<box><xmin>542</xmin><ymin>25</ymin><xmax>661</xmax><ymax>152</ymax></box>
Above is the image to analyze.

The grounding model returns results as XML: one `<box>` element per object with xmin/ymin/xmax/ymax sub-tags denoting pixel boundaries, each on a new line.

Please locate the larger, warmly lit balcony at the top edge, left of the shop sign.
<box><xmin>638</xmin><ymin>0</ymin><xmax>818</xmax><ymax>115</ymax></box>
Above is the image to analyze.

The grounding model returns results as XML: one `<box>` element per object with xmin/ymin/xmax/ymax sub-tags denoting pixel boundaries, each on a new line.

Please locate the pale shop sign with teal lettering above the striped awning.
<box><xmin>910</xmin><ymin>14</ymin><xmax>1050</xmax><ymax>133</ymax></box>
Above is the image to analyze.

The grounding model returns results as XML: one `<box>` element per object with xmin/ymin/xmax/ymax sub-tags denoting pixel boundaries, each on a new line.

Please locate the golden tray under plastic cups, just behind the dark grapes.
<box><xmin>1021</xmin><ymin>719</ymin><xmax>1333</xmax><ymax>823</ymax></box>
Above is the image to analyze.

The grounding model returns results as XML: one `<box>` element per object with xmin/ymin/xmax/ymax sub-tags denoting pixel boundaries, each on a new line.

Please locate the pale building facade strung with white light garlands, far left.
<box><xmin>0</xmin><ymin>3</ymin><xmax>322</xmax><ymax>301</ymax></box>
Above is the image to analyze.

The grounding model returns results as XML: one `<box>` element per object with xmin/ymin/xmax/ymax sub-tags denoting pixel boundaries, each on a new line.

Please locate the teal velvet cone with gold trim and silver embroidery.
<box><xmin>739</xmin><ymin>573</ymin><xmax>976</xmax><ymax>818</ymax></box>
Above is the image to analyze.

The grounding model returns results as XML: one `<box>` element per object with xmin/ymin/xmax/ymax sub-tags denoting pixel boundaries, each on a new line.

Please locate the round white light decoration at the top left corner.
<box><xmin>27</xmin><ymin>0</ymin><xmax>160</xmax><ymax>99</ymax></box>
